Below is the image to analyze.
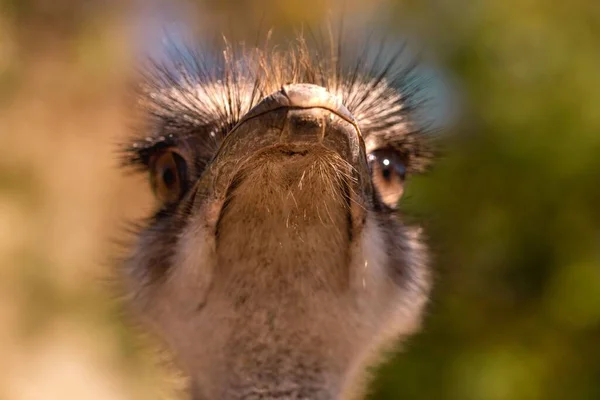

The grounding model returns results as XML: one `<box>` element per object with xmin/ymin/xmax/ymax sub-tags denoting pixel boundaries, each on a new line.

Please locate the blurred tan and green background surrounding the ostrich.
<box><xmin>0</xmin><ymin>0</ymin><xmax>600</xmax><ymax>400</ymax></box>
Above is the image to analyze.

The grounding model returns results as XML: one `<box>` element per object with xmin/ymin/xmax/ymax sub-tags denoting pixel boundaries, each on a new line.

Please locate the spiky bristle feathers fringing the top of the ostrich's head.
<box><xmin>122</xmin><ymin>29</ymin><xmax>432</xmax><ymax>172</ymax></box>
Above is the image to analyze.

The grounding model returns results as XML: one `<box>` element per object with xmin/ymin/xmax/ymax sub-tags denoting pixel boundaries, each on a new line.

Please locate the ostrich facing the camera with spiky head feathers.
<box><xmin>123</xmin><ymin>35</ymin><xmax>431</xmax><ymax>400</ymax></box>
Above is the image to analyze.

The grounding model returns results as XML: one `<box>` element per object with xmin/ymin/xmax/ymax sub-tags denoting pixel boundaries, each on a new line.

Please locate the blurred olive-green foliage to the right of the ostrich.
<box><xmin>373</xmin><ymin>0</ymin><xmax>600</xmax><ymax>400</ymax></box>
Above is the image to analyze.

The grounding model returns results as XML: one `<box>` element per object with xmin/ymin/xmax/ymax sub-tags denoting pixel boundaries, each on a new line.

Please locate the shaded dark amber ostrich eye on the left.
<box><xmin>150</xmin><ymin>149</ymin><xmax>187</xmax><ymax>204</ymax></box>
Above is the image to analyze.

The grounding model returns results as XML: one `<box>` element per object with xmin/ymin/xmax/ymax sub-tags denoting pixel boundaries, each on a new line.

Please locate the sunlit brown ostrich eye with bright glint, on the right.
<box><xmin>368</xmin><ymin>149</ymin><xmax>406</xmax><ymax>208</ymax></box>
